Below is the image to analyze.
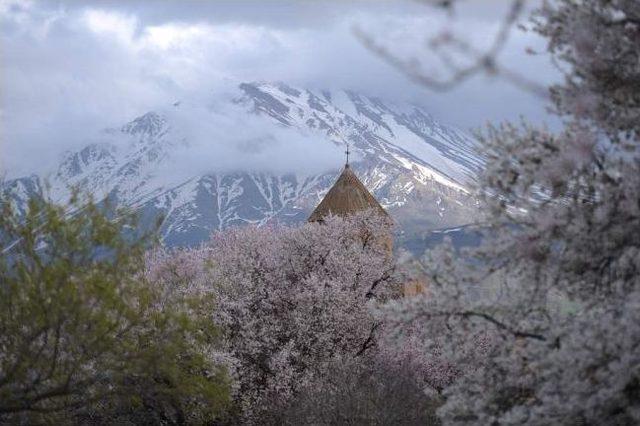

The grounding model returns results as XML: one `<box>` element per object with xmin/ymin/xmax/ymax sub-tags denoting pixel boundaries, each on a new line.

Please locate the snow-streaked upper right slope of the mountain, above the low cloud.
<box><xmin>240</xmin><ymin>83</ymin><xmax>481</xmax><ymax>189</ymax></box>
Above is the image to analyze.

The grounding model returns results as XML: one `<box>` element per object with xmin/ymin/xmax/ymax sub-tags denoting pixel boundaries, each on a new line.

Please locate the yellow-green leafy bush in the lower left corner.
<box><xmin>0</xmin><ymin>193</ymin><xmax>228</xmax><ymax>423</ymax></box>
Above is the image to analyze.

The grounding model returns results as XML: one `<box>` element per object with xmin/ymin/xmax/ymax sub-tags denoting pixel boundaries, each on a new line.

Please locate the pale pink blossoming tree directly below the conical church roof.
<box><xmin>206</xmin><ymin>212</ymin><xmax>397</xmax><ymax>422</ymax></box>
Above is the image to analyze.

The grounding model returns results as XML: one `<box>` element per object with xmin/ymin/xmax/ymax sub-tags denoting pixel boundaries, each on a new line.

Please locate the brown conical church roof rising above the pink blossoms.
<box><xmin>309</xmin><ymin>164</ymin><xmax>388</xmax><ymax>222</ymax></box>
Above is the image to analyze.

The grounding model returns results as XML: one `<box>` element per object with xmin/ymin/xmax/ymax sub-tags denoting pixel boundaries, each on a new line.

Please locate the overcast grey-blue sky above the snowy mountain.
<box><xmin>0</xmin><ymin>0</ymin><xmax>558</xmax><ymax>175</ymax></box>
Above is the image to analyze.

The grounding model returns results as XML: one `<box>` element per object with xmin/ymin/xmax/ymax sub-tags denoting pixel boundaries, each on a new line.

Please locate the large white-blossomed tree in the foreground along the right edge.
<box><xmin>387</xmin><ymin>0</ymin><xmax>640</xmax><ymax>425</ymax></box>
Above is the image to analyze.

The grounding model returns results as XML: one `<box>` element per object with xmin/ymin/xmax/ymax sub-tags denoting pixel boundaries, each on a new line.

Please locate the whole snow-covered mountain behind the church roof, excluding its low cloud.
<box><xmin>4</xmin><ymin>83</ymin><xmax>482</xmax><ymax>246</ymax></box>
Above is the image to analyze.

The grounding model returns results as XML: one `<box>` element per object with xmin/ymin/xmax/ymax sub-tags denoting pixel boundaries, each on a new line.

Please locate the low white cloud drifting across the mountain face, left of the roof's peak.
<box><xmin>161</xmin><ymin>100</ymin><xmax>344</xmax><ymax>179</ymax></box>
